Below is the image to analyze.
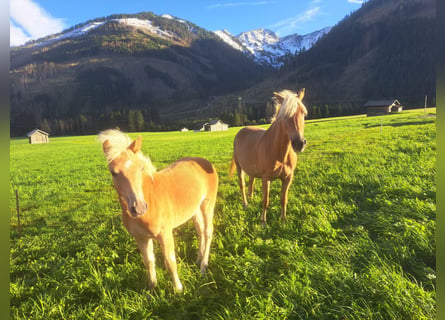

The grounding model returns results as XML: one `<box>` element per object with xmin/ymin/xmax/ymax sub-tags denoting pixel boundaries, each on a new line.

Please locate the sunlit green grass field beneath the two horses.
<box><xmin>10</xmin><ymin>109</ymin><xmax>436</xmax><ymax>320</ymax></box>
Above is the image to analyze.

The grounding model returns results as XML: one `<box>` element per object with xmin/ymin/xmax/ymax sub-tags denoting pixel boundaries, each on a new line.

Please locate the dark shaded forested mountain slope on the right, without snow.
<box><xmin>220</xmin><ymin>0</ymin><xmax>436</xmax><ymax>118</ymax></box>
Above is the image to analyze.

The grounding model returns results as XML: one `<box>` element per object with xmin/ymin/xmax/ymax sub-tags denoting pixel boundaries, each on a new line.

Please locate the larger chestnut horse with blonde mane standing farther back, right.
<box><xmin>229</xmin><ymin>88</ymin><xmax>307</xmax><ymax>225</ymax></box>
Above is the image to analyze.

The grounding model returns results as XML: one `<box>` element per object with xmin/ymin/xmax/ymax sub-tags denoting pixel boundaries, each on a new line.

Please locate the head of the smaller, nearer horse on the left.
<box><xmin>99</xmin><ymin>130</ymin><xmax>151</xmax><ymax>217</ymax></box>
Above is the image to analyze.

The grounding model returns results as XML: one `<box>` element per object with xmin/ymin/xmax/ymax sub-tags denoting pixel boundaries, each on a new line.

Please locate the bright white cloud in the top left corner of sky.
<box><xmin>10</xmin><ymin>0</ymin><xmax>66</xmax><ymax>45</ymax></box>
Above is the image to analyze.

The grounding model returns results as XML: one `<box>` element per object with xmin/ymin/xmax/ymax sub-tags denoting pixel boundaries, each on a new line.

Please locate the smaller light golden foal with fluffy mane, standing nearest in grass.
<box><xmin>98</xmin><ymin>129</ymin><xmax>218</xmax><ymax>291</ymax></box>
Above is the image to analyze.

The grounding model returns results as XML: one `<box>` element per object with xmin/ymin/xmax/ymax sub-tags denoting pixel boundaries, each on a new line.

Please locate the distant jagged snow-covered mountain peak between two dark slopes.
<box><xmin>215</xmin><ymin>27</ymin><xmax>331</xmax><ymax>68</ymax></box>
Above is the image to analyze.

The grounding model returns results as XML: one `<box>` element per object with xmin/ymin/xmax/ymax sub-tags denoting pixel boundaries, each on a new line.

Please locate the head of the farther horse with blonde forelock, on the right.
<box><xmin>274</xmin><ymin>88</ymin><xmax>307</xmax><ymax>152</ymax></box>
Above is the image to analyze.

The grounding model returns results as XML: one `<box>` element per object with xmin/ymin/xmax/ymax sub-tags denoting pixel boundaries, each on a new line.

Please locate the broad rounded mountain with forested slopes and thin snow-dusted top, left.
<box><xmin>10</xmin><ymin>12</ymin><xmax>267</xmax><ymax>135</ymax></box>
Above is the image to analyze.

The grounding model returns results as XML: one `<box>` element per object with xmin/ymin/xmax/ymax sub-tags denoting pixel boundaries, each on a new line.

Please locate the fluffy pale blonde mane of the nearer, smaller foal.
<box><xmin>97</xmin><ymin>129</ymin><xmax>156</xmax><ymax>175</ymax></box>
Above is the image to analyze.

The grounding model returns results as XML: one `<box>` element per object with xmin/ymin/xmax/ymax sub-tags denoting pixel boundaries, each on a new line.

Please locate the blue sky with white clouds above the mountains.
<box><xmin>9</xmin><ymin>0</ymin><xmax>364</xmax><ymax>46</ymax></box>
